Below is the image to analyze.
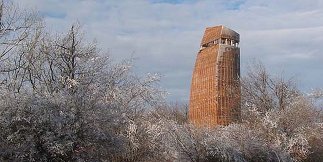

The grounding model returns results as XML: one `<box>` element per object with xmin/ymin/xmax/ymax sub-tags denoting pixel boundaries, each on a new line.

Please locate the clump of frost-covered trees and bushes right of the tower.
<box><xmin>242</xmin><ymin>61</ymin><xmax>323</xmax><ymax>161</ymax></box>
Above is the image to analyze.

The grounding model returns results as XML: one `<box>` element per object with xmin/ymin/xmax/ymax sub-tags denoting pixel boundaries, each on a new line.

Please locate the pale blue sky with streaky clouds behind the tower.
<box><xmin>13</xmin><ymin>0</ymin><xmax>323</xmax><ymax>102</ymax></box>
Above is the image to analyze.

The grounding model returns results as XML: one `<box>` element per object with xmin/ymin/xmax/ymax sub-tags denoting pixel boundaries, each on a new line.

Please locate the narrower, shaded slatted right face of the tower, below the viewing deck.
<box><xmin>216</xmin><ymin>45</ymin><xmax>240</xmax><ymax>125</ymax></box>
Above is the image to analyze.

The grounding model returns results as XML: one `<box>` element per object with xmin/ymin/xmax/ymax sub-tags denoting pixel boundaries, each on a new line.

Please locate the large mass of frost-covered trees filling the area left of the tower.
<box><xmin>0</xmin><ymin>1</ymin><xmax>167</xmax><ymax>161</ymax></box>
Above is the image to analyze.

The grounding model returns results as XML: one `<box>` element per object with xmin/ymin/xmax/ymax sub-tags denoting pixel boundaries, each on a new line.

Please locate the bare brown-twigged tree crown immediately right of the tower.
<box><xmin>241</xmin><ymin>63</ymin><xmax>301</xmax><ymax>112</ymax></box>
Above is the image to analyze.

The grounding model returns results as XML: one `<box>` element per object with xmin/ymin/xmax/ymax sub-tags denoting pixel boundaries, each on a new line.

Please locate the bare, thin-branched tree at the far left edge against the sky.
<box><xmin>0</xmin><ymin>1</ymin><xmax>43</xmax><ymax>91</ymax></box>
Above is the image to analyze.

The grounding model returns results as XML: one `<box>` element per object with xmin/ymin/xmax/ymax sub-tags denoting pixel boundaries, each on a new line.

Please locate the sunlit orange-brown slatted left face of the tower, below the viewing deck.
<box><xmin>189</xmin><ymin>45</ymin><xmax>218</xmax><ymax>125</ymax></box>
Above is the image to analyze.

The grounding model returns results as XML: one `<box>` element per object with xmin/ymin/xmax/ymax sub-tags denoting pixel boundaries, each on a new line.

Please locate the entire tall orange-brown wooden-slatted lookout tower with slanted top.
<box><xmin>189</xmin><ymin>26</ymin><xmax>240</xmax><ymax>127</ymax></box>
